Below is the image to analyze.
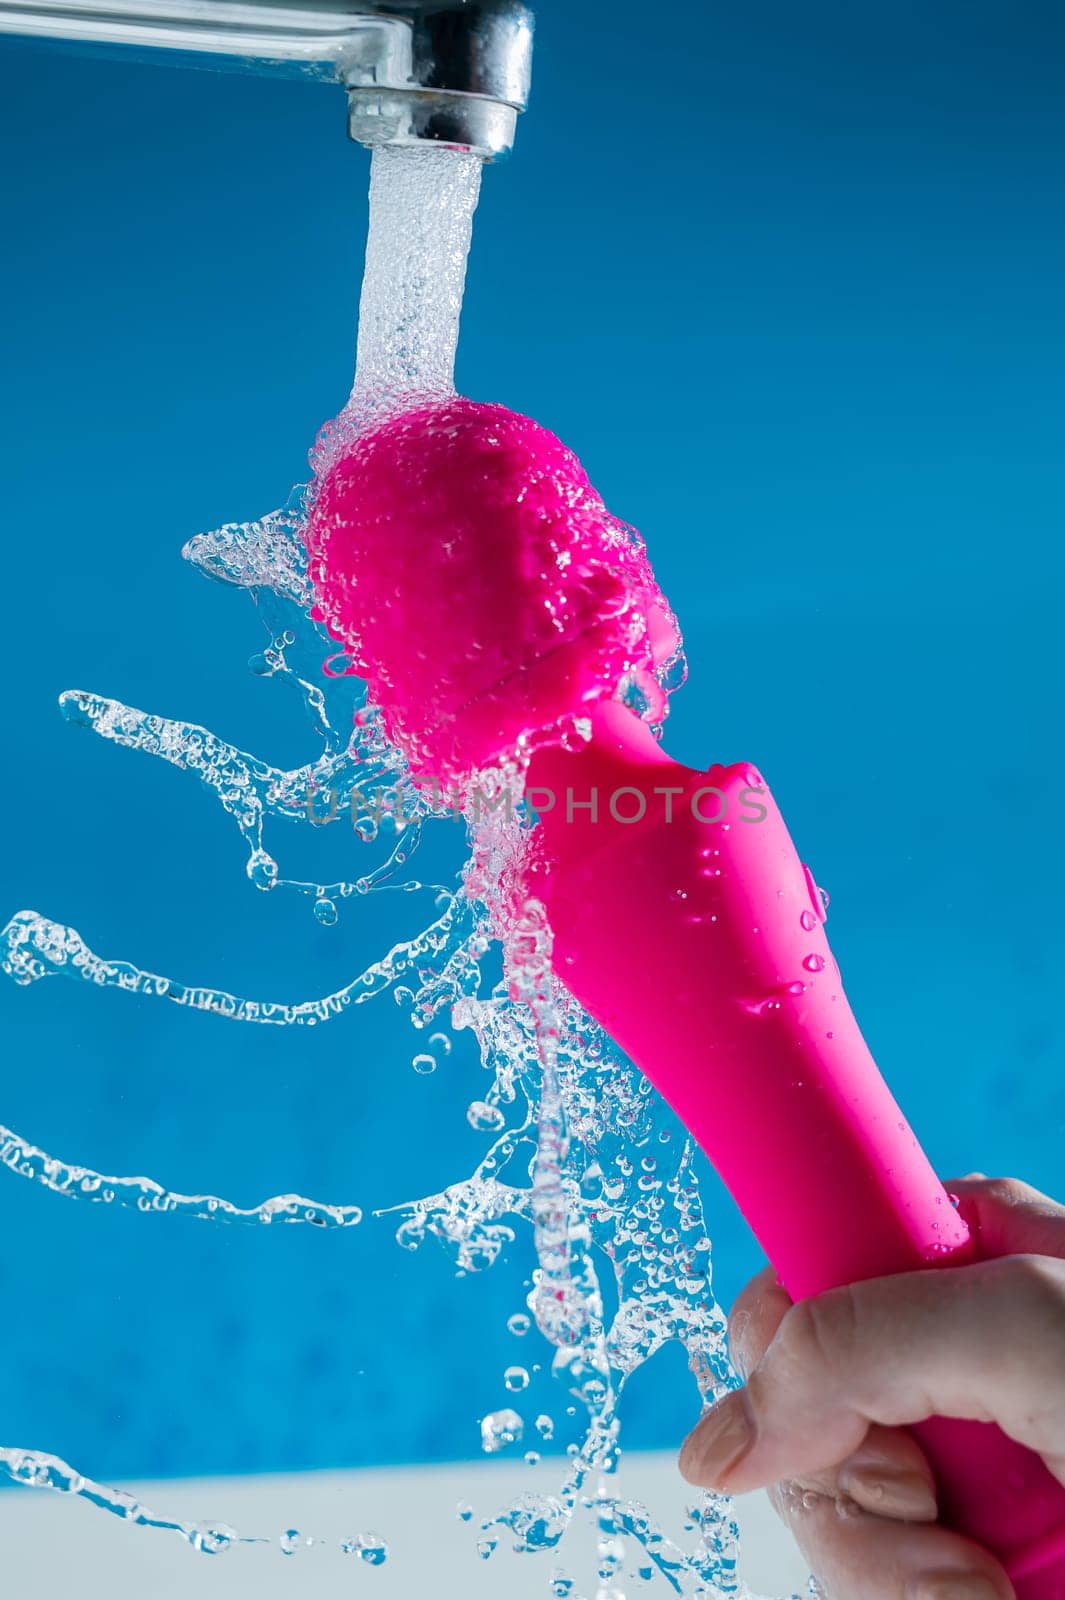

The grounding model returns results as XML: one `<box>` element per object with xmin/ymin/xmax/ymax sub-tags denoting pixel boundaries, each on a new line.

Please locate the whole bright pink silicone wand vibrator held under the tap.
<box><xmin>309</xmin><ymin>400</ymin><xmax>1065</xmax><ymax>1600</ymax></box>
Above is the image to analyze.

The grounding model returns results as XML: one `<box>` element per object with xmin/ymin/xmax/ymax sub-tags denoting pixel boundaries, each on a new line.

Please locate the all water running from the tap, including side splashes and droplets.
<box><xmin>0</xmin><ymin>149</ymin><xmax>740</xmax><ymax>1600</ymax></box>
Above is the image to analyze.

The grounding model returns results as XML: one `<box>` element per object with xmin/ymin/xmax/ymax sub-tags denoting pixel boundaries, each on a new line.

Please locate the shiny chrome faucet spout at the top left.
<box><xmin>0</xmin><ymin>0</ymin><xmax>533</xmax><ymax>160</ymax></box>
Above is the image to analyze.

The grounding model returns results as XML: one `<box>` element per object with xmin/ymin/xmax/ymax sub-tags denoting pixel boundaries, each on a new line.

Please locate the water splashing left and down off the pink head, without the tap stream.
<box><xmin>3</xmin><ymin>499</ymin><xmax>737</xmax><ymax>1595</ymax></box>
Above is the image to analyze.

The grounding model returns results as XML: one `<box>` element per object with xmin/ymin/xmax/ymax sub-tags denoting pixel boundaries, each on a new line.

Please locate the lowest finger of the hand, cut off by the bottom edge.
<box><xmin>771</xmin><ymin>1483</ymin><xmax>1012</xmax><ymax>1600</ymax></box>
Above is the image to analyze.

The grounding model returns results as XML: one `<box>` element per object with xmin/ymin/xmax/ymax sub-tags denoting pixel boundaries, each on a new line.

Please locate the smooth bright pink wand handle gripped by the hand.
<box><xmin>529</xmin><ymin>707</ymin><xmax>1065</xmax><ymax>1600</ymax></box>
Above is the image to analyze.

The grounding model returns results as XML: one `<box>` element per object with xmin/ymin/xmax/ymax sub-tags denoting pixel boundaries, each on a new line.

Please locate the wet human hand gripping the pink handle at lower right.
<box><xmin>680</xmin><ymin>1174</ymin><xmax>1065</xmax><ymax>1600</ymax></box>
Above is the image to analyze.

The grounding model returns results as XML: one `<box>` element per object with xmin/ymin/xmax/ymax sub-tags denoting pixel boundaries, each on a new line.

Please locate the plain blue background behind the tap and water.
<box><xmin>0</xmin><ymin>0</ymin><xmax>1065</xmax><ymax>1477</ymax></box>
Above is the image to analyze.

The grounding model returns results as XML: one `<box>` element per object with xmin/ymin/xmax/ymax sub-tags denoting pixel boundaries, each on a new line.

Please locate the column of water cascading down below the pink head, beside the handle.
<box><xmin>437</xmin><ymin>800</ymin><xmax>739</xmax><ymax>1597</ymax></box>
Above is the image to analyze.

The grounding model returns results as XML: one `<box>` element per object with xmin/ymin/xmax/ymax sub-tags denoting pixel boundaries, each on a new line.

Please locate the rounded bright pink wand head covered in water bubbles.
<box><xmin>307</xmin><ymin>398</ymin><xmax>680</xmax><ymax>782</ymax></box>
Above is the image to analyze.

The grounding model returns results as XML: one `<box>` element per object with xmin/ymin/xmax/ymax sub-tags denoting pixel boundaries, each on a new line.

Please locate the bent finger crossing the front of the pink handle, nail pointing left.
<box><xmin>681</xmin><ymin>1256</ymin><xmax>1065</xmax><ymax>1493</ymax></box>
